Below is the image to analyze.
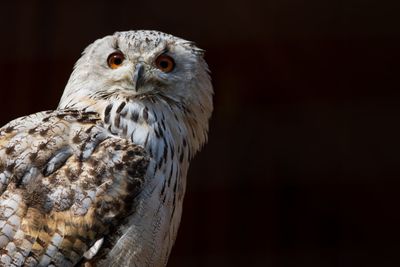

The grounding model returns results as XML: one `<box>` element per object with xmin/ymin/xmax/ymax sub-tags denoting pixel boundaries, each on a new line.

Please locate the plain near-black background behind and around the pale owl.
<box><xmin>0</xmin><ymin>0</ymin><xmax>400</xmax><ymax>267</ymax></box>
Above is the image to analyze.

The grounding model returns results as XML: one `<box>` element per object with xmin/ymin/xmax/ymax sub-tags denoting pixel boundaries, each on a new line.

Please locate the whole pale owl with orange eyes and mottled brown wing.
<box><xmin>0</xmin><ymin>30</ymin><xmax>213</xmax><ymax>267</ymax></box>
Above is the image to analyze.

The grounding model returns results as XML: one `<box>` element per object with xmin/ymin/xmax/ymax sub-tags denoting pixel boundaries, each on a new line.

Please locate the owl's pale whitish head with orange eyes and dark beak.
<box><xmin>59</xmin><ymin>30</ymin><xmax>213</xmax><ymax>153</ymax></box>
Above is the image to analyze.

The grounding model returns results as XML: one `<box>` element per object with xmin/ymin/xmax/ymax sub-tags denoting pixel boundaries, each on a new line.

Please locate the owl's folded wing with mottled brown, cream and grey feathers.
<box><xmin>0</xmin><ymin>110</ymin><xmax>148</xmax><ymax>266</ymax></box>
